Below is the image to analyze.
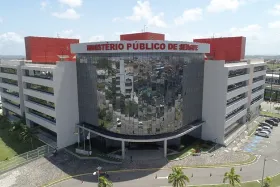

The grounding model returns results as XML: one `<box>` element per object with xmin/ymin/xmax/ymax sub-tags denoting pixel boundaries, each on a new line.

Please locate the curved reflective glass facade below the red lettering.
<box><xmin>77</xmin><ymin>53</ymin><xmax>204</xmax><ymax>135</ymax></box>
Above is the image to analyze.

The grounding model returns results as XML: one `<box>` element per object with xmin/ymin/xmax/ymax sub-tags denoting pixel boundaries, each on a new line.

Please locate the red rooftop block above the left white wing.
<box><xmin>24</xmin><ymin>36</ymin><xmax>79</xmax><ymax>64</ymax></box>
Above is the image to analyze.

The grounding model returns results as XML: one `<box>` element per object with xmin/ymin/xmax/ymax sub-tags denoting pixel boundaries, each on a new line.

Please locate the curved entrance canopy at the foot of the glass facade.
<box><xmin>78</xmin><ymin>121</ymin><xmax>205</xmax><ymax>142</ymax></box>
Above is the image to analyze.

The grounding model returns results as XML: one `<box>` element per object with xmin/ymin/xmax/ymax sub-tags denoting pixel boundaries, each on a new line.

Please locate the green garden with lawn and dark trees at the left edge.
<box><xmin>0</xmin><ymin>115</ymin><xmax>44</xmax><ymax>161</ymax></box>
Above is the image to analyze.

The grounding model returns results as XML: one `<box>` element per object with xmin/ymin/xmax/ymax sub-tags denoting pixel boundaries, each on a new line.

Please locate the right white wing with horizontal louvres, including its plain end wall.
<box><xmin>202</xmin><ymin>60</ymin><xmax>266</xmax><ymax>145</ymax></box>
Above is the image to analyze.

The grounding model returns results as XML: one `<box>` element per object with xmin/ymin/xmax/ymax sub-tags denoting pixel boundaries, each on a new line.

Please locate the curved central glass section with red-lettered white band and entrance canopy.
<box><xmin>71</xmin><ymin>40</ymin><xmax>209</xmax><ymax>157</ymax></box>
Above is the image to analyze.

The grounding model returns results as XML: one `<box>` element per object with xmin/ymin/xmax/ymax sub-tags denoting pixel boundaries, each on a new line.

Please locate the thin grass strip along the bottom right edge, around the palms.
<box><xmin>190</xmin><ymin>175</ymin><xmax>280</xmax><ymax>187</ymax></box>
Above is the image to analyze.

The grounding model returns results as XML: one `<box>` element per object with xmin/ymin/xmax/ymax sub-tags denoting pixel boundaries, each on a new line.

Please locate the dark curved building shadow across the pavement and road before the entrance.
<box><xmin>46</xmin><ymin>150</ymin><xmax>168</xmax><ymax>183</ymax></box>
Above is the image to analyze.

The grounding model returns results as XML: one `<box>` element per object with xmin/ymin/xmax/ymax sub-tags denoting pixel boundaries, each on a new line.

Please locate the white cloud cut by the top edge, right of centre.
<box><xmin>206</xmin><ymin>0</ymin><xmax>243</xmax><ymax>13</ymax></box>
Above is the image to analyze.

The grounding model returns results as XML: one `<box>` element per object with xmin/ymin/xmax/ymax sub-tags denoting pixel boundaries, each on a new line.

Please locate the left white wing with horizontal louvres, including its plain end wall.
<box><xmin>0</xmin><ymin>62</ymin><xmax>79</xmax><ymax>148</ymax></box>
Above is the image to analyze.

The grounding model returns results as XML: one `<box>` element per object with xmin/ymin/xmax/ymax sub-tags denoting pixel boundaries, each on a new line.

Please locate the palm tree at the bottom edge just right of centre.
<box><xmin>168</xmin><ymin>167</ymin><xmax>190</xmax><ymax>187</ymax></box>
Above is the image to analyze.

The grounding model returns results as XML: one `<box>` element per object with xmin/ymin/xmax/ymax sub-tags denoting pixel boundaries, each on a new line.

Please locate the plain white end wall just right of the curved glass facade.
<box><xmin>202</xmin><ymin>60</ymin><xmax>228</xmax><ymax>144</ymax></box>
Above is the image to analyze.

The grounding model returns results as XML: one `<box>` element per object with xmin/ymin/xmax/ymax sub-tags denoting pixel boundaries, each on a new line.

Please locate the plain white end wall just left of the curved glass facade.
<box><xmin>53</xmin><ymin>62</ymin><xmax>79</xmax><ymax>148</ymax></box>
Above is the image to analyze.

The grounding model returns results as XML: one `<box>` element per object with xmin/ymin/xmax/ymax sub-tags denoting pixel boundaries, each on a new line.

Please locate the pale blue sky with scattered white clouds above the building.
<box><xmin>0</xmin><ymin>0</ymin><xmax>280</xmax><ymax>55</ymax></box>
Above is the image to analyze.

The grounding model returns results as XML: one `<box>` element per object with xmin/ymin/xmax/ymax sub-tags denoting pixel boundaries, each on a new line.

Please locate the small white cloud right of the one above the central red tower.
<box><xmin>174</xmin><ymin>8</ymin><xmax>202</xmax><ymax>25</ymax></box>
